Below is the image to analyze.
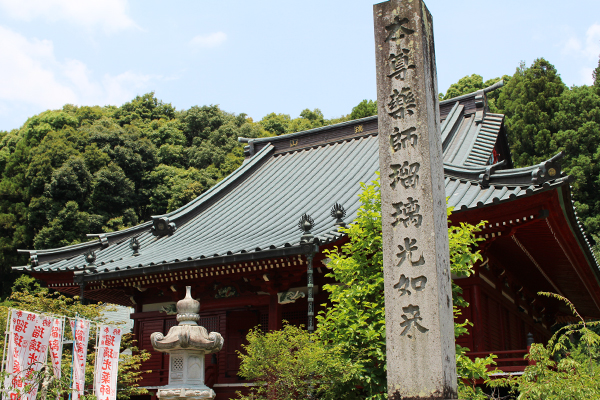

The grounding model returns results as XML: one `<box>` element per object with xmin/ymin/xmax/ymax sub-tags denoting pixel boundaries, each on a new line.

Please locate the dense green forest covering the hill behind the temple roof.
<box><xmin>0</xmin><ymin>59</ymin><xmax>600</xmax><ymax>297</ymax></box>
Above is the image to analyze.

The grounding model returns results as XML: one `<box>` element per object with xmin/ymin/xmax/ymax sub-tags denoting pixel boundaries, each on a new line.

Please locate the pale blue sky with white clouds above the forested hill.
<box><xmin>0</xmin><ymin>0</ymin><xmax>600</xmax><ymax>130</ymax></box>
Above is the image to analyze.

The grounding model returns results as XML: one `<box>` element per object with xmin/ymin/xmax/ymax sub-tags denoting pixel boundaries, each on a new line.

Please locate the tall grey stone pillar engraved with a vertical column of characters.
<box><xmin>373</xmin><ymin>0</ymin><xmax>457</xmax><ymax>399</ymax></box>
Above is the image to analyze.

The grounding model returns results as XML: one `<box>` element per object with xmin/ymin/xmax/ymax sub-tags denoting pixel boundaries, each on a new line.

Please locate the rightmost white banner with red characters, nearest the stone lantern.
<box><xmin>94</xmin><ymin>325</ymin><xmax>122</xmax><ymax>400</ymax></box>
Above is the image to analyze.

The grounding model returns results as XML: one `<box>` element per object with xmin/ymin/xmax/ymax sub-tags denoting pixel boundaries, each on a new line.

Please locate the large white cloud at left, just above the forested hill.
<box><xmin>0</xmin><ymin>26</ymin><xmax>161</xmax><ymax>115</ymax></box>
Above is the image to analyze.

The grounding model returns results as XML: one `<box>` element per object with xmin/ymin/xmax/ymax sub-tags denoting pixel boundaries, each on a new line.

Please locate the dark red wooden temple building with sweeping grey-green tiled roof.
<box><xmin>15</xmin><ymin>85</ymin><xmax>600</xmax><ymax>399</ymax></box>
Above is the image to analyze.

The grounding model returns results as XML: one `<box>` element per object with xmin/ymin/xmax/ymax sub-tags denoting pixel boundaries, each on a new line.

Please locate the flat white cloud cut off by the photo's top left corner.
<box><xmin>0</xmin><ymin>0</ymin><xmax>137</xmax><ymax>32</ymax></box>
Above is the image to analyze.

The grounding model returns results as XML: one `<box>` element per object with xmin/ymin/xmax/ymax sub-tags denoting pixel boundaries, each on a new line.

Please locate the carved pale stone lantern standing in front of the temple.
<box><xmin>150</xmin><ymin>286</ymin><xmax>223</xmax><ymax>400</ymax></box>
